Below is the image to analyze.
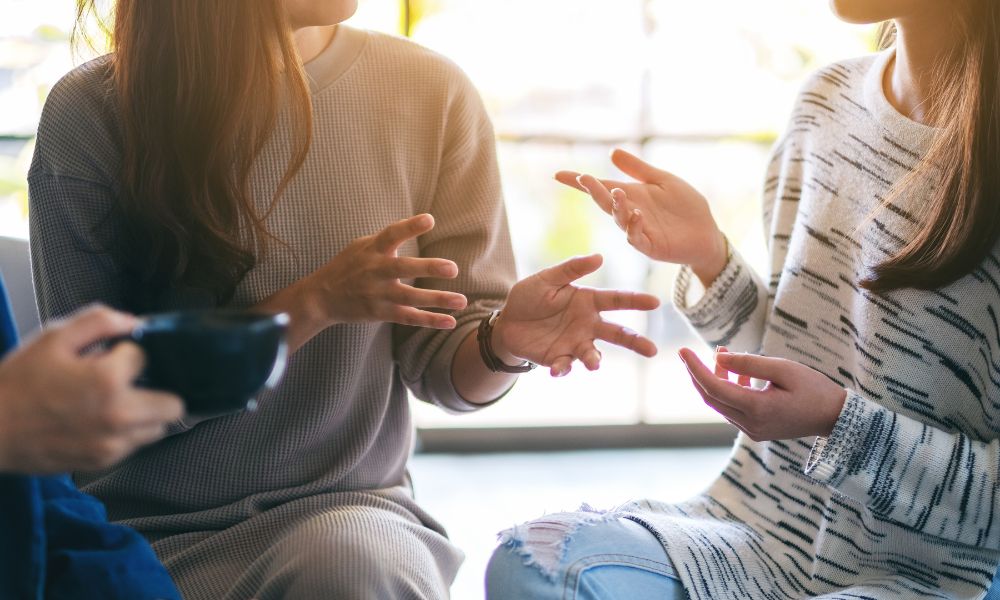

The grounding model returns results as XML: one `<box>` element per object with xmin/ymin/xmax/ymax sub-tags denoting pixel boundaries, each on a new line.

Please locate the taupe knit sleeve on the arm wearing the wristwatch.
<box><xmin>396</xmin><ymin>69</ymin><xmax>516</xmax><ymax>413</ymax></box>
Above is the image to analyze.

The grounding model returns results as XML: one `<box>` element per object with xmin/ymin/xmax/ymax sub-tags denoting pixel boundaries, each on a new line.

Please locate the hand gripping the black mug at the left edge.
<box><xmin>0</xmin><ymin>308</ymin><xmax>184</xmax><ymax>474</ymax></box>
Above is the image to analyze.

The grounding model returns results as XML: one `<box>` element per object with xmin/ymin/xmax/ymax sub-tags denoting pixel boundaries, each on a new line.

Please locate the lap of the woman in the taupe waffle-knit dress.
<box><xmin>150</xmin><ymin>492</ymin><xmax>462</xmax><ymax>600</ymax></box>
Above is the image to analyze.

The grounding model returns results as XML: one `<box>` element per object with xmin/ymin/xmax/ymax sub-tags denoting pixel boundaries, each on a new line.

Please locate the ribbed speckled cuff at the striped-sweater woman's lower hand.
<box><xmin>805</xmin><ymin>390</ymin><xmax>868</xmax><ymax>488</ymax></box>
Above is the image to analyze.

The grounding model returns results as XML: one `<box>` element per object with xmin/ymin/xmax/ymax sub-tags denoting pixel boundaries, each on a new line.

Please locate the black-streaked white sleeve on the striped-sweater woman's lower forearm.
<box><xmin>805</xmin><ymin>391</ymin><xmax>1000</xmax><ymax>550</ymax></box>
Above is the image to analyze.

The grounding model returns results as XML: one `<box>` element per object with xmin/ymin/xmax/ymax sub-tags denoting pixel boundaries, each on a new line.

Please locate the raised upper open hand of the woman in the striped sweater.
<box><xmin>556</xmin><ymin>150</ymin><xmax>726</xmax><ymax>272</ymax></box>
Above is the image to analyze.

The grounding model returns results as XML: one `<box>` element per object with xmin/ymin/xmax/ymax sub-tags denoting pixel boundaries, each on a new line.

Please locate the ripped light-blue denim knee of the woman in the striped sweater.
<box><xmin>486</xmin><ymin>510</ymin><xmax>688</xmax><ymax>600</ymax></box>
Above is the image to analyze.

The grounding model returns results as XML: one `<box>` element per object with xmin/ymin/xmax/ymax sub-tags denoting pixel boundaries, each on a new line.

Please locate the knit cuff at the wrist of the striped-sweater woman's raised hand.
<box><xmin>674</xmin><ymin>247</ymin><xmax>762</xmax><ymax>352</ymax></box>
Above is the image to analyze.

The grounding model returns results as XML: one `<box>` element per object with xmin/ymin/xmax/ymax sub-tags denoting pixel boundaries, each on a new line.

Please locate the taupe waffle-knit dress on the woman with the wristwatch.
<box><xmin>29</xmin><ymin>27</ymin><xmax>514</xmax><ymax>600</ymax></box>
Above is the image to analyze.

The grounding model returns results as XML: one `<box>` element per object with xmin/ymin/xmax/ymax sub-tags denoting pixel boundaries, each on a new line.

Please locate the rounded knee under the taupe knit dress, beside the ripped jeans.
<box><xmin>242</xmin><ymin>506</ymin><xmax>462</xmax><ymax>600</ymax></box>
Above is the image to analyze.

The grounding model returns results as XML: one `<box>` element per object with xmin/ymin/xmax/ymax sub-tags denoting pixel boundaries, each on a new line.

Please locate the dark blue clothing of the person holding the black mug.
<box><xmin>0</xmin><ymin>277</ymin><xmax>180</xmax><ymax>600</ymax></box>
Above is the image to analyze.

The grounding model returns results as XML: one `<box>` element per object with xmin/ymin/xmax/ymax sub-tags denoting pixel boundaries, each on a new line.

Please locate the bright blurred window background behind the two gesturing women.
<box><xmin>0</xmin><ymin>0</ymin><xmax>876</xmax><ymax>598</ymax></box>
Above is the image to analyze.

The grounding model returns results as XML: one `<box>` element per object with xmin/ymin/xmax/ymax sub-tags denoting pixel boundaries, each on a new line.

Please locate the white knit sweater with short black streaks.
<box><xmin>627</xmin><ymin>51</ymin><xmax>1000</xmax><ymax>599</ymax></box>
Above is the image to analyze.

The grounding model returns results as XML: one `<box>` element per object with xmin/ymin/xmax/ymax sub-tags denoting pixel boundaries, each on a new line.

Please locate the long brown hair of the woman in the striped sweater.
<box><xmin>861</xmin><ymin>0</ymin><xmax>1000</xmax><ymax>292</ymax></box>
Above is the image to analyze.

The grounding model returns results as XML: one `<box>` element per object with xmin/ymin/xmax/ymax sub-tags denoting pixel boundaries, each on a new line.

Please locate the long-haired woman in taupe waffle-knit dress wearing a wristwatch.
<box><xmin>30</xmin><ymin>0</ymin><xmax>657</xmax><ymax>600</ymax></box>
